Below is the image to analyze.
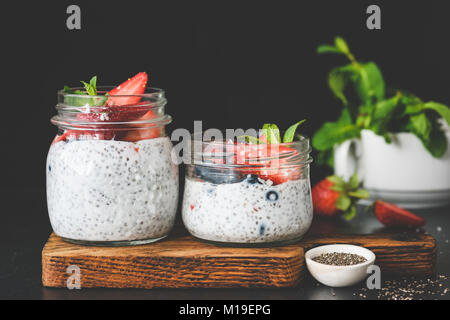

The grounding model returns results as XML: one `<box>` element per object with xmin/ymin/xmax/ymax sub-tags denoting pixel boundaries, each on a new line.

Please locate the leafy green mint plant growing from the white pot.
<box><xmin>312</xmin><ymin>37</ymin><xmax>450</xmax><ymax>167</ymax></box>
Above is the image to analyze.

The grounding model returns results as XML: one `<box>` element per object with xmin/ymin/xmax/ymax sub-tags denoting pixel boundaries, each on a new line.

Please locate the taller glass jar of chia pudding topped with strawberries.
<box><xmin>46</xmin><ymin>87</ymin><xmax>178</xmax><ymax>246</ymax></box>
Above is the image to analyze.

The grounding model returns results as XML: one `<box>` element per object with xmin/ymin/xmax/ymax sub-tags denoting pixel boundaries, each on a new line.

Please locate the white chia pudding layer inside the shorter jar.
<box><xmin>182</xmin><ymin>178</ymin><xmax>312</xmax><ymax>243</ymax></box>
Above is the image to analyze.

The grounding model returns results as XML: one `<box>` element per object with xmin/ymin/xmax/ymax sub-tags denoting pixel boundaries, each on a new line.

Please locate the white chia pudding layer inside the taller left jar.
<box><xmin>47</xmin><ymin>137</ymin><xmax>178</xmax><ymax>241</ymax></box>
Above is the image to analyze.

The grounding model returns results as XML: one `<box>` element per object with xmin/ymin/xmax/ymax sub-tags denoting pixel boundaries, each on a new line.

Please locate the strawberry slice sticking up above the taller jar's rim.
<box><xmin>106</xmin><ymin>72</ymin><xmax>148</xmax><ymax>106</ymax></box>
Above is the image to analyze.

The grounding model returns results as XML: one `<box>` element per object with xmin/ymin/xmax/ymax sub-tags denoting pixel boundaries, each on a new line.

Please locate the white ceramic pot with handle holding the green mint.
<box><xmin>334</xmin><ymin>130</ymin><xmax>450</xmax><ymax>208</ymax></box>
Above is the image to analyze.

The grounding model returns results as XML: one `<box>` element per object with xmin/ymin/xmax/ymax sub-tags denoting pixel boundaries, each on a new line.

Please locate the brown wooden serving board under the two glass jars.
<box><xmin>42</xmin><ymin>232</ymin><xmax>436</xmax><ymax>289</ymax></box>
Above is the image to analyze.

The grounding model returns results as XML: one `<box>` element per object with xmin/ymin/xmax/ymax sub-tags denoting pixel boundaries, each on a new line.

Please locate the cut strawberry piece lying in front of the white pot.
<box><xmin>374</xmin><ymin>200</ymin><xmax>425</xmax><ymax>228</ymax></box>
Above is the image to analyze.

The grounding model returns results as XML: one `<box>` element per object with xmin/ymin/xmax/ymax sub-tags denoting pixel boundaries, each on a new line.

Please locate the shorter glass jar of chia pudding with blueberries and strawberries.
<box><xmin>182</xmin><ymin>137</ymin><xmax>312</xmax><ymax>247</ymax></box>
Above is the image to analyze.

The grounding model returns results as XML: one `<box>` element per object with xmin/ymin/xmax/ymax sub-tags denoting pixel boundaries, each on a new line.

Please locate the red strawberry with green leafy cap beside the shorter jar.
<box><xmin>311</xmin><ymin>174</ymin><xmax>369</xmax><ymax>220</ymax></box>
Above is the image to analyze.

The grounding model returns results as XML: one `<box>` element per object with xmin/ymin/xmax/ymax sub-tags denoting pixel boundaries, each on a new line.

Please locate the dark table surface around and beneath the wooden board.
<box><xmin>0</xmin><ymin>189</ymin><xmax>450</xmax><ymax>300</ymax></box>
